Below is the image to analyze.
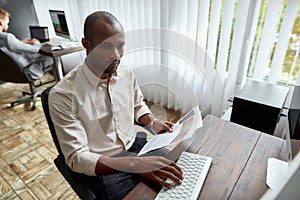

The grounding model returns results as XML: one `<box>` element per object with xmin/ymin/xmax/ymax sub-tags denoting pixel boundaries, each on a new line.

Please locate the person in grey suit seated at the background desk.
<box><xmin>0</xmin><ymin>8</ymin><xmax>53</xmax><ymax>80</ymax></box>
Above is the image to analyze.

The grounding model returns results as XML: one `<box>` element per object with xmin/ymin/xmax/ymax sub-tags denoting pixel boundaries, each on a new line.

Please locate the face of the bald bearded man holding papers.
<box><xmin>87</xmin><ymin>19</ymin><xmax>125</xmax><ymax>76</ymax></box>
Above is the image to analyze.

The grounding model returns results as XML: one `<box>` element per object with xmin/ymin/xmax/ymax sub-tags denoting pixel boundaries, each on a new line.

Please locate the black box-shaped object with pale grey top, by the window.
<box><xmin>230</xmin><ymin>81</ymin><xmax>289</xmax><ymax>135</ymax></box>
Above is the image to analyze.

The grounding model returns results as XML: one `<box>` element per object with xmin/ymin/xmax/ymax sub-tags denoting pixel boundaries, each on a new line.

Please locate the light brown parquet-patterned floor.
<box><xmin>0</xmin><ymin>74</ymin><xmax>180</xmax><ymax>200</ymax></box>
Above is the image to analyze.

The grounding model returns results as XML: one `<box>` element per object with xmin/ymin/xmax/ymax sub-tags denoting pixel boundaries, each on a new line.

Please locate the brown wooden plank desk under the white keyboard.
<box><xmin>125</xmin><ymin>115</ymin><xmax>299</xmax><ymax>200</ymax></box>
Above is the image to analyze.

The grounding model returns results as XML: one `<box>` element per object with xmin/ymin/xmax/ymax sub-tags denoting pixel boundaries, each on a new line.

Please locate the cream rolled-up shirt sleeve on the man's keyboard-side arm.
<box><xmin>49</xmin><ymin>88</ymin><xmax>101</xmax><ymax>176</ymax></box>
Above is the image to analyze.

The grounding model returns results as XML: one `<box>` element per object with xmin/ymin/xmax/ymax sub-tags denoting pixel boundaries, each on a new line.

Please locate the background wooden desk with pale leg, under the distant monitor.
<box><xmin>40</xmin><ymin>46</ymin><xmax>84</xmax><ymax>81</ymax></box>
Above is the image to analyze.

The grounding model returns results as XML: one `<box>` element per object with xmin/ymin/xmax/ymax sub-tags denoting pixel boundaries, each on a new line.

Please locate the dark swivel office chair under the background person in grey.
<box><xmin>0</xmin><ymin>47</ymin><xmax>54</xmax><ymax>110</ymax></box>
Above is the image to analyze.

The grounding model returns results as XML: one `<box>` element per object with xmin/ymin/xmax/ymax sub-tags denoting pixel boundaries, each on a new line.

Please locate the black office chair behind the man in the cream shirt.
<box><xmin>41</xmin><ymin>87</ymin><xmax>96</xmax><ymax>200</ymax></box>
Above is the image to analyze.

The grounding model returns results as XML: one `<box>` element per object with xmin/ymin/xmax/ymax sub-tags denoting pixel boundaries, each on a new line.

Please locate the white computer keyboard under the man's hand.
<box><xmin>155</xmin><ymin>152</ymin><xmax>212</xmax><ymax>200</ymax></box>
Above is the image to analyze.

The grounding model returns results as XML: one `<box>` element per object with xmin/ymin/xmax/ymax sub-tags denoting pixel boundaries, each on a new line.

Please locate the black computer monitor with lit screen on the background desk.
<box><xmin>49</xmin><ymin>10</ymin><xmax>70</xmax><ymax>39</ymax></box>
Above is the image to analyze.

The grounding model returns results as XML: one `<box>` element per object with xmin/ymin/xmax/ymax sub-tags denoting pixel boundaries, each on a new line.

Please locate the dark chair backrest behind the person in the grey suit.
<box><xmin>0</xmin><ymin>47</ymin><xmax>30</xmax><ymax>83</ymax></box>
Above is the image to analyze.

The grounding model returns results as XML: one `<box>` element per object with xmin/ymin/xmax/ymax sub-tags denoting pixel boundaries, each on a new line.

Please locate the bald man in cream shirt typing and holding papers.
<box><xmin>49</xmin><ymin>11</ymin><xmax>183</xmax><ymax>199</ymax></box>
